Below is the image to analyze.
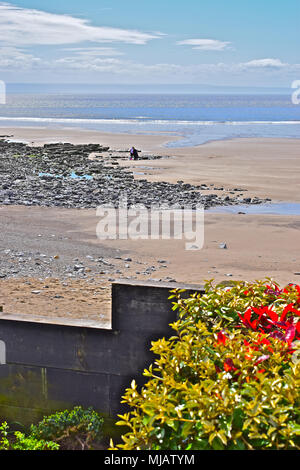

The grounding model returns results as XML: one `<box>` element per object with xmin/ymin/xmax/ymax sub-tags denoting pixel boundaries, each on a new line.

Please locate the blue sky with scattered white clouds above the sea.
<box><xmin>0</xmin><ymin>0</ymin><xmax>300</xmax><ymax>88</ymax></box>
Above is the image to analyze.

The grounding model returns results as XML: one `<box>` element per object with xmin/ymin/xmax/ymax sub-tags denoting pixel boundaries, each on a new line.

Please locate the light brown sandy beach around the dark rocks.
<box><xmin>0</xmin><ymin>128</ymin><xmax>300</xmax><ymax>321</ymax></box>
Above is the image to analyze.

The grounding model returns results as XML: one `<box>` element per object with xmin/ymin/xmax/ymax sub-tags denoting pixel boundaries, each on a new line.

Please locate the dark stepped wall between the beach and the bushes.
<box><xmin>0</xmin><ymin>282</ymin><xmax>202</xmax><ymax>425</ymax></box>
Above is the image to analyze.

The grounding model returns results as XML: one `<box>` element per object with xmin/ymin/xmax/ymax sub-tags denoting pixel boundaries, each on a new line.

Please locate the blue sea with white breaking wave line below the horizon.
<box><xmin>0</xmin><ymin>92</ymin><xmax>300</xmax><ymax>148</ymax></box>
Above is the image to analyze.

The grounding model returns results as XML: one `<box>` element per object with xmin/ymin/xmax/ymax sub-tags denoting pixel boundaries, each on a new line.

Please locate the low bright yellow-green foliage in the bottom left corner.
<box><xmin>0</xmin><ymin>422</ymin><xmax>59</xmax><ymax>450</ymax></box>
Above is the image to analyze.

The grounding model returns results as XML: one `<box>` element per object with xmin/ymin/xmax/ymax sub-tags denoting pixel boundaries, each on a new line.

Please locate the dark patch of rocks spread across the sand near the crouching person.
<box><xmin>0</xmin><ymin>141</ymin><xmax>270</xmax><ymax>213</ymax></box>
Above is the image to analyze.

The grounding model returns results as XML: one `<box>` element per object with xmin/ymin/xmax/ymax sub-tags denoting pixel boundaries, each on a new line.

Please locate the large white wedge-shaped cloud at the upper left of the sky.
<box><xmin>0</xmin><ymin>3</ymin><xmax>159</xmax><ymax>46</ymax></box>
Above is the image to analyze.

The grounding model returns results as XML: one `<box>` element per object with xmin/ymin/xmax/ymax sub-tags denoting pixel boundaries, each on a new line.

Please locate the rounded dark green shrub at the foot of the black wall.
<box><xmin>30</xmin><ymin>406</ymin><xmax>103</xmax><ymax>450</ymax></box>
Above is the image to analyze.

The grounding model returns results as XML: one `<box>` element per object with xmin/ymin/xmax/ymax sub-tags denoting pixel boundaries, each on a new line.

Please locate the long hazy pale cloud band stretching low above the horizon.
<box><xmin>0</xmin><ymin>41</ymin><xmax>300</xmax><ymax>84</ymax></box>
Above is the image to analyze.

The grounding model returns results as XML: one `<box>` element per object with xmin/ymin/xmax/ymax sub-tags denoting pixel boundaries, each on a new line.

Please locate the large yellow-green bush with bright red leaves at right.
<box><xmin>111</xmin><ymin>281</ymin><xmax>300</xmax><ymax>450</ymax></box>
